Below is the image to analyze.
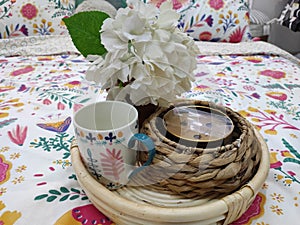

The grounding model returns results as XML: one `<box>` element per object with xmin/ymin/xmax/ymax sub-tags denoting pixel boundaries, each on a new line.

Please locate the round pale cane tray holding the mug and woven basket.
<box><xmin>71</xmin><ymin>126</ymin><xmax>270</xmax><ymax>225</ymax></box>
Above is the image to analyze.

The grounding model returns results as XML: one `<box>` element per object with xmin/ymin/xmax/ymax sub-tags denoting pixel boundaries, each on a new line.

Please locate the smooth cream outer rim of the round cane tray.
<box><xmin>71</xmin><ymin>129</ymin><xmax>269</xmax><ymax>222</ymax></box>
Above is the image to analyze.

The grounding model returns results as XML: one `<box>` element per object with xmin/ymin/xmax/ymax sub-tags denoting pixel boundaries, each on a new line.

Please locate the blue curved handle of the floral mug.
<box><xmin>128</xmin><ymin>133</ymin><xmax>155</xmax><ymax>179</ymax></box>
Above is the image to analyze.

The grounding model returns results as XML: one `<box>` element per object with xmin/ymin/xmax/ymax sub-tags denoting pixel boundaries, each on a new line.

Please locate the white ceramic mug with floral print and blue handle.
<box><xmin>73</xmin><ymin>101</ymin><xmax>155</xmax><ymax>189</ymax></box>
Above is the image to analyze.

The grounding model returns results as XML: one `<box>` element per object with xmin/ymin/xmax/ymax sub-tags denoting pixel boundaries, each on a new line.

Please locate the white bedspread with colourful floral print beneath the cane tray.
<box><xmin>0</xmin><ymin>44</ymin><xmax>300</xmax><ymax>225</ymax></box>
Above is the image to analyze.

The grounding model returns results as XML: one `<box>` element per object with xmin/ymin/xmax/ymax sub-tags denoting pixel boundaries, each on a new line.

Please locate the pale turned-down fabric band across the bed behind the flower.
<box><xmin>0</xmin><ymin>35</ymin><xmax>300</xmax><ymax>63</ymax></box>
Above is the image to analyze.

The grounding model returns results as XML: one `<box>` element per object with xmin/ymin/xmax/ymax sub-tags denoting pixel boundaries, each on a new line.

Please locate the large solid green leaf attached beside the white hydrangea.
<box><xmin>63</xmin><ymin>11</ymin><xmax>109</xmax><ymax>57</ymax></box>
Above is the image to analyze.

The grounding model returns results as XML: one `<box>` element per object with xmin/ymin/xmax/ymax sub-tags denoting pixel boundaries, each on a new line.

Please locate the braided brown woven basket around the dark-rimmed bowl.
<box><xmin>137</xmin><ymin>100</ymin><xmax>262</xmax><ymax>198</ymax></box>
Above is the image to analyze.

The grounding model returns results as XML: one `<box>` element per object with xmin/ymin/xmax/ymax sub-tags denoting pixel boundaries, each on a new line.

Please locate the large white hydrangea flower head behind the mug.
<box><xmin>87</xmin><ymin>0</ymin><xmax>198</xmax><ymax>105</ymax></box>
